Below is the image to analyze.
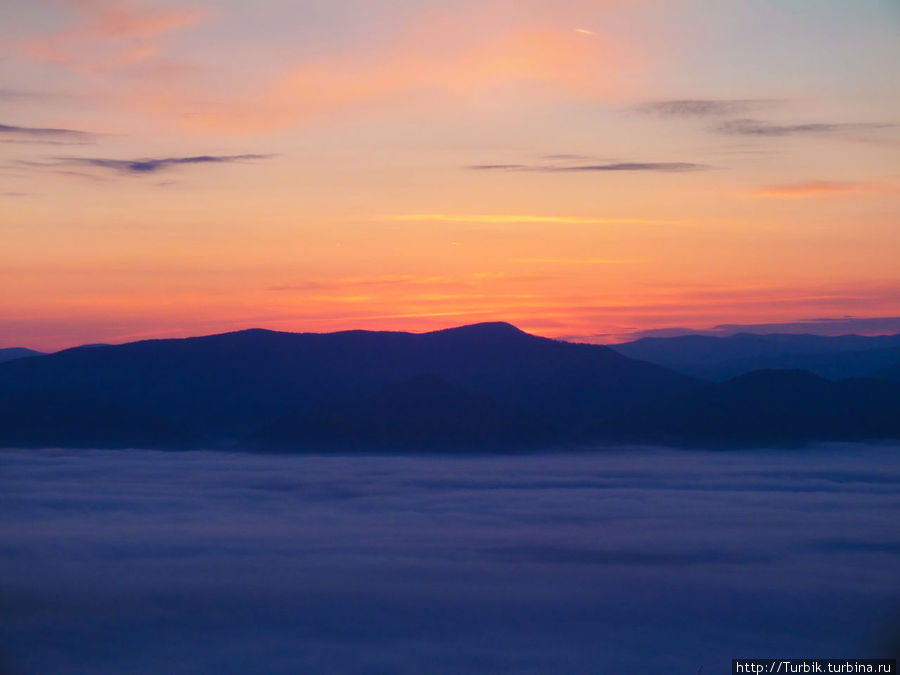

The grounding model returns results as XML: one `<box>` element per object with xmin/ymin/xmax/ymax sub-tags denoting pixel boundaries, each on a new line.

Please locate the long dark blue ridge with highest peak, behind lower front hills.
<box><xmin>0</xmin><ymin>323</ymin><xmax>696</xmax><ymax>444</ymax></box>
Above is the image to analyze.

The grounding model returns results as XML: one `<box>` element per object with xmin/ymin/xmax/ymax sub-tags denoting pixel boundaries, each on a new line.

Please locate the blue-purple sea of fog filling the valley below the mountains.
<box><xmin>0</xmin><ymin>445</ymin><xmax>900</xmax><ymax>675</ymax></box>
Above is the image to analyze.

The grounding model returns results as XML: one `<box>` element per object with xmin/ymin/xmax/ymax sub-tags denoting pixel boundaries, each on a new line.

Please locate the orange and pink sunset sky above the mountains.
<box><xmin>0</xmin><ymin>0</ymin><xmax>900</xmax><ymax>350</ymax></box>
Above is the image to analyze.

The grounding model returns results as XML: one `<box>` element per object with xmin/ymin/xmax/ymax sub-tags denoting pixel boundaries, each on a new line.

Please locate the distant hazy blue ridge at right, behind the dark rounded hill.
<box><xmin>611</xmin><ymin>333</ymin><xmax>900</xmax><ymax>381</ymax></box>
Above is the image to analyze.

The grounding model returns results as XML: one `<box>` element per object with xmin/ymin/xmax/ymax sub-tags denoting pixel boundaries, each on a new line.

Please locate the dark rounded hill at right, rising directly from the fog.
<box><xmin>595</xmin><ymin>370</ymin><xmax>900</xmax><ymax>445</ymax></box>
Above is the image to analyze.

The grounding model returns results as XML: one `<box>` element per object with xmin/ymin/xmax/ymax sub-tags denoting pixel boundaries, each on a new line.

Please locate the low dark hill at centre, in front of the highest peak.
<box><xmin>255</xmin><ymin>375</ymin><xmax>559</xmax><ymax>450</ymax></box>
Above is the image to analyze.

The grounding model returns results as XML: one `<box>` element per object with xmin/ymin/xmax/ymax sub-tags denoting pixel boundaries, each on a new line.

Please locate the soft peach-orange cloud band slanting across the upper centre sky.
<box><xmin>179</xmin><ymin>26</ymin><xmax>624</xmax><ymax>131</ymax></box>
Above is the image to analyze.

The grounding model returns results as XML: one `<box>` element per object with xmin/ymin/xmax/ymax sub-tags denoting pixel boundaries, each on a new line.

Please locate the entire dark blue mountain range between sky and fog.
<box><xmin>0</xmin><ymin>323</ymin><xmax>900</xmax><ymax>451</ymax></box>
